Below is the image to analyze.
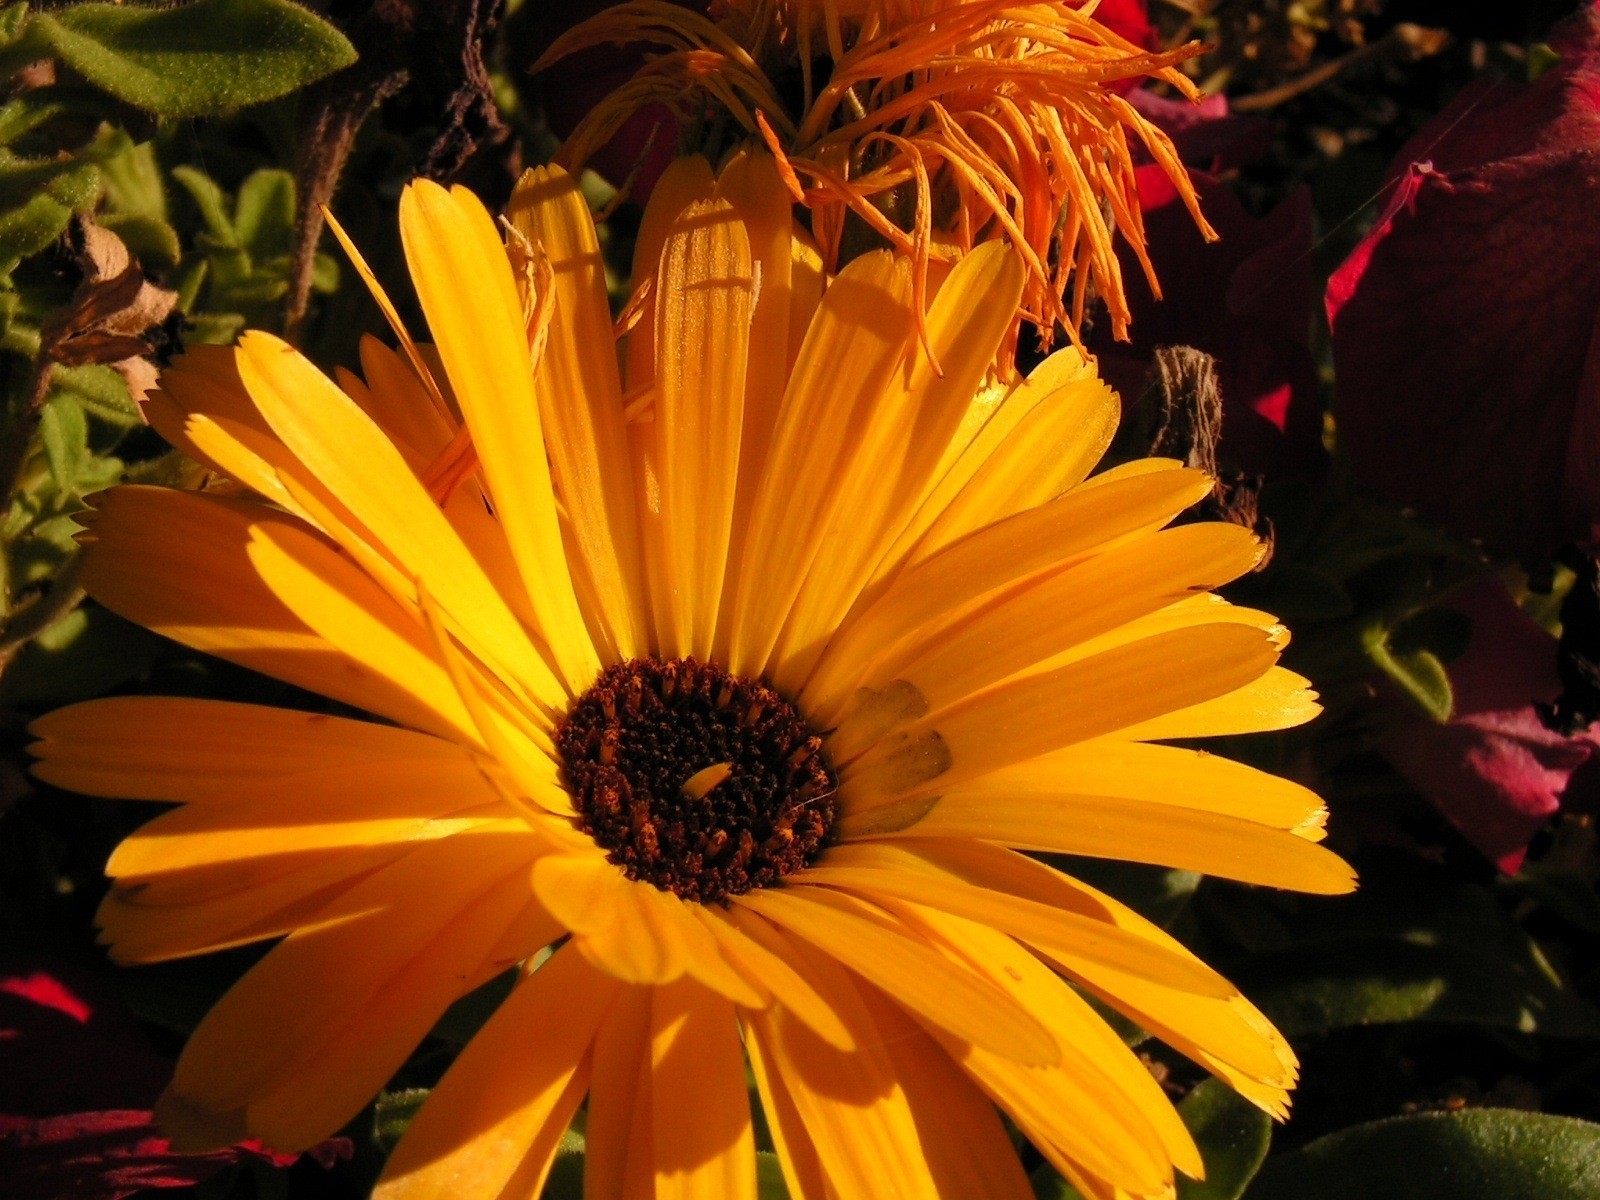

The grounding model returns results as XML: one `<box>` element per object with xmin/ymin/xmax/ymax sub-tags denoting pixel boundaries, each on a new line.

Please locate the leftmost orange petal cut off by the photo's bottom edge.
<box><xmin>373</xmin><ymin>947</ymin><xmax>618</xmax><ymax>1200</ymax></box>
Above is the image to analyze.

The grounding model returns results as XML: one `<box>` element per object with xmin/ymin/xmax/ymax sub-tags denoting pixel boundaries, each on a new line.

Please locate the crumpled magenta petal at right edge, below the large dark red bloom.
<box><xmin>1382</xmin><ymin>579</ymin><xmax>1595</xmax><ymax>872</ymax></box>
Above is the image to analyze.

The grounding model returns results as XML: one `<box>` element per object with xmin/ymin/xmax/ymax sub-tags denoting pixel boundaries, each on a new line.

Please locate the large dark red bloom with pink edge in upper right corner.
<box><xmin>1326</xmin><ymin>5</ymin><xmax>1600</xmax><ymax>562</ymax></box>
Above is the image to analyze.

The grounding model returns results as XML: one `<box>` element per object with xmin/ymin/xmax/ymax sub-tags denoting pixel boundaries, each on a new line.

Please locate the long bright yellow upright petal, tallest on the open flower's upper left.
<box><xmin>393</xmin><ymin>181</ymin><xmax>600</xmax><ymax>694</ymax></box>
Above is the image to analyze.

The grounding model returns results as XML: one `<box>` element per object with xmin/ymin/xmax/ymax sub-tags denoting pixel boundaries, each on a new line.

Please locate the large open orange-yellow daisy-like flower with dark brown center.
<box><xmin>34</xmin><ymin>152</ymin><xmax>1350</xmax><ymax>1200</ymax></box>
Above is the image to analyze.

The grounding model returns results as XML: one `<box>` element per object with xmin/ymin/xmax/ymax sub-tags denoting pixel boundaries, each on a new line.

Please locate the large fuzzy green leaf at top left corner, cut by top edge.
<box><xmin>29</xmin><ymin>0</ymin><xmax>355</xmax><ymax>117</ymax></box>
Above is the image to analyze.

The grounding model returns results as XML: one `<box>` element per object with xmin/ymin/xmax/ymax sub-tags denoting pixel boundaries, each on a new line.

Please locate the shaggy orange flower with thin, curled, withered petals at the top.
<box><xmin>536</xmin><ymin>0</ymin><xmax>1216</xmax><ymax>356</ymax></box>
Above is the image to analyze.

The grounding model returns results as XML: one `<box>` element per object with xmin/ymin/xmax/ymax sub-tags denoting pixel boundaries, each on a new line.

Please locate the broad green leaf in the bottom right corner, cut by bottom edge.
<box><xmin>1245</xmin><ymin>1109</ymin><xmax>1600</xmax><ymax>1200</ymax></box>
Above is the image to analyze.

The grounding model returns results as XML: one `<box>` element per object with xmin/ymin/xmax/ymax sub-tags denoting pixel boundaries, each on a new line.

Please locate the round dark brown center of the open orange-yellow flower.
<box><xmin>555</xmin><ymin>658</ymin><xmax>838</xmax><ymax>902</ymax></box>
